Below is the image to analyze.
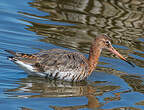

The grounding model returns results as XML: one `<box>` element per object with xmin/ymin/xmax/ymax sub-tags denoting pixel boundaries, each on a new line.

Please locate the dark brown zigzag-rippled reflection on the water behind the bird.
<box><xmin>20</xmin><ymin>0</ymin><xmax>144</xmax><ymax>67</ymax></box>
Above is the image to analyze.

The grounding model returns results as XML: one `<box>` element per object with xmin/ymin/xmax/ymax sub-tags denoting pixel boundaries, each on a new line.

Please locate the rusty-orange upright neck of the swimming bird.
<box><xmin>88</xmin><ymin>44</ymin><xmax>102</xmax><ymax>74</ymax></box>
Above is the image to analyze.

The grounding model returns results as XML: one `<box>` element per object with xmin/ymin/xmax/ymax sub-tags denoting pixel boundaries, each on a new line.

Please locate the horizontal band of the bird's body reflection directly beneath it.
<box><xmin>6</xmin><ymin>77</ymin><xmax>119</xmax><ymax>98</ymax></box>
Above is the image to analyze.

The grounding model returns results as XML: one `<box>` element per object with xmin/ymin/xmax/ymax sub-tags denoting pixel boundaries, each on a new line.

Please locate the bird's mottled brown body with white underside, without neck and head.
<box><xmin>7</xmin><ymin>49</ymin><xmax>89</xmax><ymax>81</ymax></box>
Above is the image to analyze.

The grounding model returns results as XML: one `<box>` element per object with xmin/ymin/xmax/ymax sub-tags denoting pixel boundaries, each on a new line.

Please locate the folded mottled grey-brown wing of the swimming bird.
<box><xmin>35</xmin><ymin>49</ymin><xmax>88</xmax><ymax>71</ymax></box>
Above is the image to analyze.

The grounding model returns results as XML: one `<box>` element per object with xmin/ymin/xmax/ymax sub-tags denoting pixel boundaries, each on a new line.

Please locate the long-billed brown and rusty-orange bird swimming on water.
<box><xmin>5</xmin><ymin>34</ymin><xmax>134</xmax><ymax>82</ymax></box>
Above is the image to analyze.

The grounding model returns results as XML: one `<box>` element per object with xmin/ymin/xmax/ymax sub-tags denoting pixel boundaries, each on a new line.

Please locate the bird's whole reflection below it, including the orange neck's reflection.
<box><xmin>5</xmin><ymin>77</ymin><xmax>120</xmax><ymax>110</ymax></box>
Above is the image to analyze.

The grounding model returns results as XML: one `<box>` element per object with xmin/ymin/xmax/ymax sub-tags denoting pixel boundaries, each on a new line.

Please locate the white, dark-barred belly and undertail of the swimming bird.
<box><xmin>15</xmin><ymin>61</ymin><xmax>87</xmax><ymax>81</ymax></box>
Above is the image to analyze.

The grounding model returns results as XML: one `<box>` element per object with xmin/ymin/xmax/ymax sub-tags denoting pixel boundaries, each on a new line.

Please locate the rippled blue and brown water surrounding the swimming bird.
<box><xmin>0</xmin><ymin>0</ymin><xmax>144</xmax><ymax>110</ymax></box>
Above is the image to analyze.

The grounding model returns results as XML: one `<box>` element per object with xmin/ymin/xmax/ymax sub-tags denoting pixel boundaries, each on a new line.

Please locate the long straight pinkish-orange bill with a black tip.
<box><xmin>108</xmin><ymin>46</ymin><xmax>135</xmax><ymax>67</ymax></box>
